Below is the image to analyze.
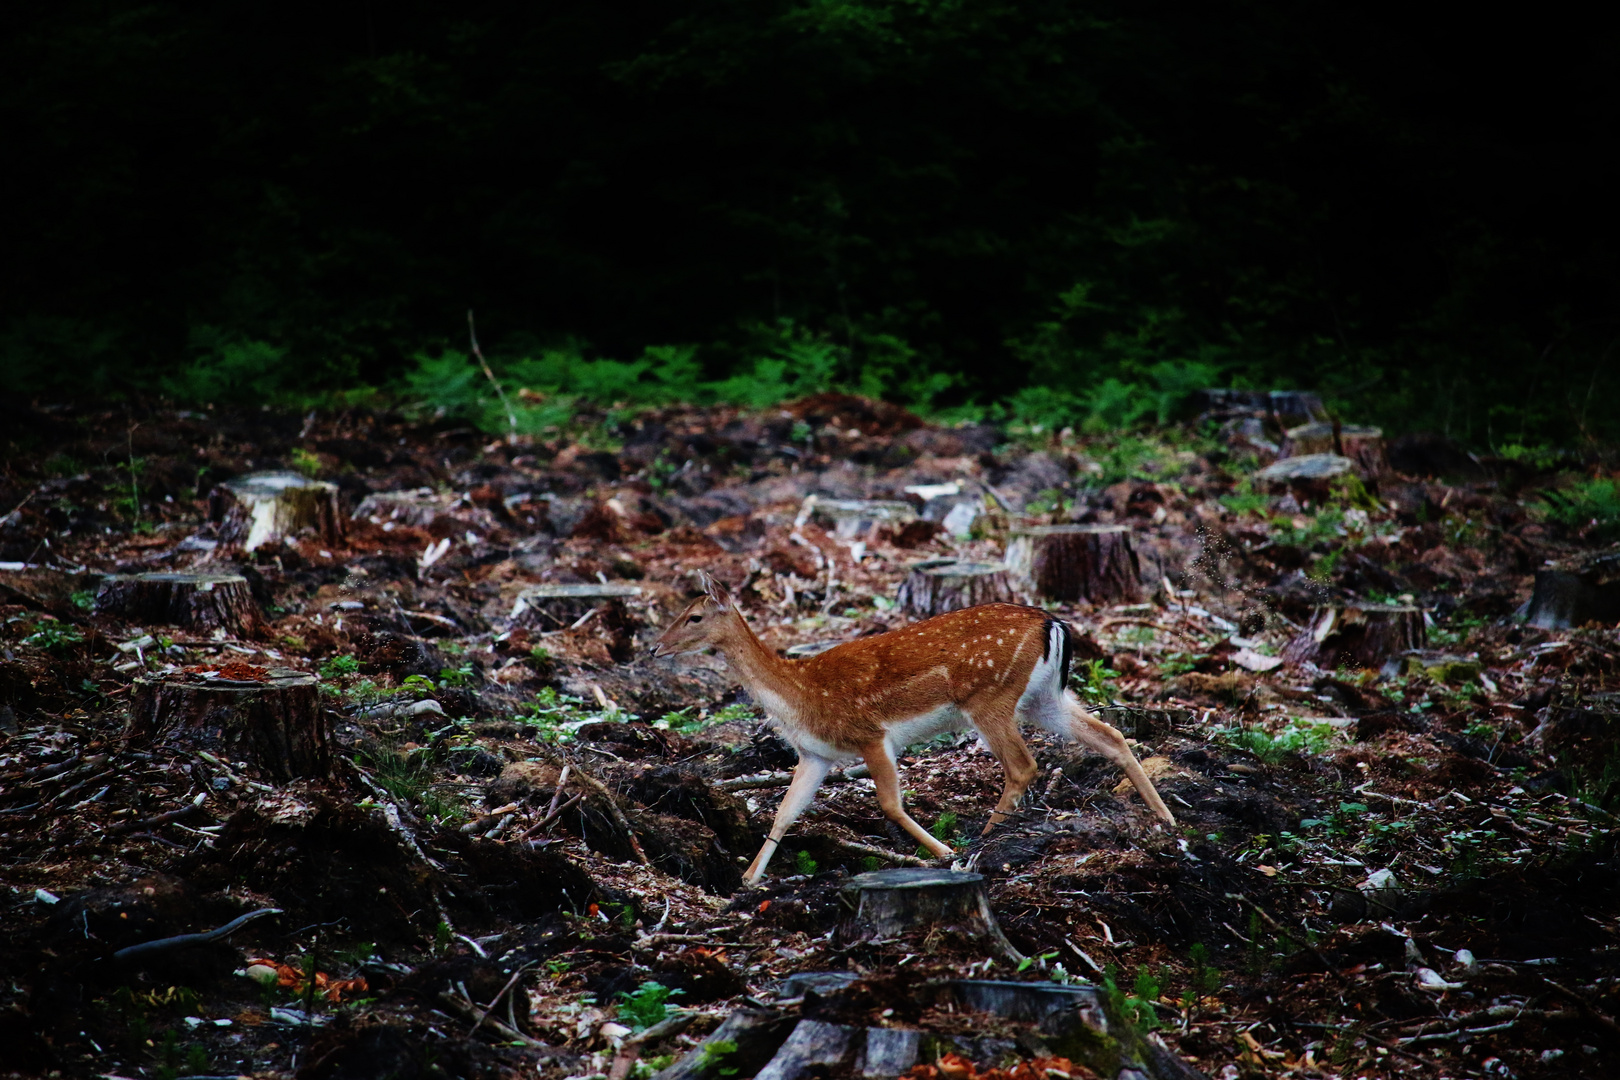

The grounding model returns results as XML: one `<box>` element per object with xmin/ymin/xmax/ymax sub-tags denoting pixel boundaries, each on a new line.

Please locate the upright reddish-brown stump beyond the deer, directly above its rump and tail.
<box><xmin>1008</xmin><ymin>525</ymin><xmax>1142</xmax><ymax>604</ymax></box>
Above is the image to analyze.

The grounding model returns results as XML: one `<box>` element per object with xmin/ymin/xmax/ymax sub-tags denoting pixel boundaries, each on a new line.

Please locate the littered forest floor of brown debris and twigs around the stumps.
<box><xmin>0</xmin><ymin>395</ymin><xmax>1620</xmax><ymax>1080</ymax></box>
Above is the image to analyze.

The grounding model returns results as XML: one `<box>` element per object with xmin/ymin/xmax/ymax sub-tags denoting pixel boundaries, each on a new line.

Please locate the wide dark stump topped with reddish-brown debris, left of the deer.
<box><xmin>130</xmin><ymin>661</ymin><xmax>332</xmax><ymax>780</ymax></box>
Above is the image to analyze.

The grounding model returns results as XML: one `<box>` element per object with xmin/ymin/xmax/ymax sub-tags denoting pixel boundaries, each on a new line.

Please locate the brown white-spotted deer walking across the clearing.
<box><xmin>651</xmin><ymin>572</ymin><xmax>1176</xmax><ymax>887</ymax></box>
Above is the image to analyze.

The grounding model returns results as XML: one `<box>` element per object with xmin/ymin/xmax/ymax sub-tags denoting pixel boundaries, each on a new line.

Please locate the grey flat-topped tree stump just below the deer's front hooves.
<box><xmin>834</xmin><ymin>870</ymin><xmax>1024</xmax><ymax>963</ymax></box>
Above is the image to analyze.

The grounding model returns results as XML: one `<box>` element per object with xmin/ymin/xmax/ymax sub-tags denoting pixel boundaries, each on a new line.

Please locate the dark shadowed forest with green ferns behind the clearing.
<box><xmin>0</xmin><ymin>0</ymin><xmax>1620</xmax><ymax>447</ymax></box>
